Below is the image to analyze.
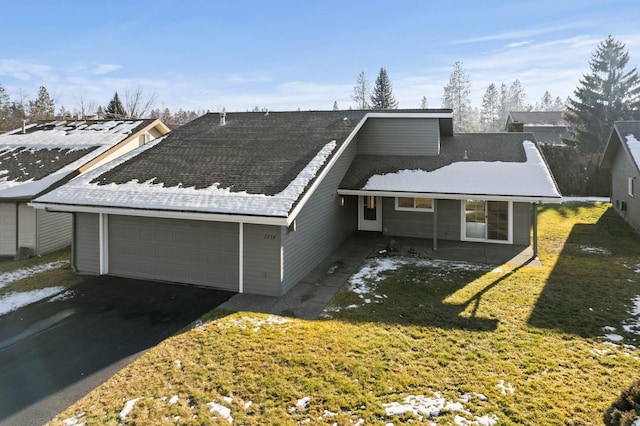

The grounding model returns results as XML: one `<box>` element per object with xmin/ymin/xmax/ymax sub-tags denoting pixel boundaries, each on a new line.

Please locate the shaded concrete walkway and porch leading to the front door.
<box><xmin>219</xmin><ymin>232</ymin><xmax>540</xmax><ymax>320</ymax></box>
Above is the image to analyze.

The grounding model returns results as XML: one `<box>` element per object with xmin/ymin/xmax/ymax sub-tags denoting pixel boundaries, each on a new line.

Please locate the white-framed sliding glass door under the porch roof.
<box><xmin>462</xmin><ymin>200</ymin><xmax>512</xmax><ymax>243</ymax></box>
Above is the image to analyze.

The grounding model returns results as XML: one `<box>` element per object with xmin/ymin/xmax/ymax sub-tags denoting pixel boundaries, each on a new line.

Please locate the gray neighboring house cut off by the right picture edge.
<box><xmin>600</xmin><ymin>121</ymin><xmax>640</xmax><ymax>232</ymax></box>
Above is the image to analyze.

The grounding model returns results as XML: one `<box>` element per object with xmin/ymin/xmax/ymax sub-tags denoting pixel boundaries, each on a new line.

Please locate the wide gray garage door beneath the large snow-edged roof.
<box><xmin>109</xmin><ymin>216</ymin><xmax>238</xmax><ymax>291</ymax></box>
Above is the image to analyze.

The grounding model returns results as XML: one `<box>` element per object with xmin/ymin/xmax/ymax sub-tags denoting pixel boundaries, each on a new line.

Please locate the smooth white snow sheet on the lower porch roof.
<box><xmin>362</xmin><ymin>141</ymin><xmax>561</xmax><ymax>198</ymax></box>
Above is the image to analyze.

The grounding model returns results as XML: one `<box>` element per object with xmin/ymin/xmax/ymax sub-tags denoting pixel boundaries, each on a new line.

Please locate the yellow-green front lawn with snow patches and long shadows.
<box><xmin>51</xmin><ymin>203</ymin><xmax>640</xmax><ymax>425</ymax></box>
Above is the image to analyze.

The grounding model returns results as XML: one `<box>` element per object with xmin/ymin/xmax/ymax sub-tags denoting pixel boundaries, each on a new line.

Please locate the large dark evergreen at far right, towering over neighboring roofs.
<box><xmin>564</xmin><ymin>36</ymin><xmax>640</xmax><ymax>153</ymax></box>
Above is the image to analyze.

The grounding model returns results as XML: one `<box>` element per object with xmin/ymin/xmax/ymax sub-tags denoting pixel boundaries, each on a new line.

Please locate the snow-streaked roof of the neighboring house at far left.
<box><xmin>0</xmin><ymin>120</ymin><xmax>168</xmax><ymax>200</ymax></box>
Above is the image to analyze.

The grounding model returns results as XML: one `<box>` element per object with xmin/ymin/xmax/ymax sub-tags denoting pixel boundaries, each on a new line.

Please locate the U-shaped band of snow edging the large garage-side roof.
<box><xmin>35</xmin><ymin>138</ymin><xmax>337</xmax><ymax>217</ymax></box>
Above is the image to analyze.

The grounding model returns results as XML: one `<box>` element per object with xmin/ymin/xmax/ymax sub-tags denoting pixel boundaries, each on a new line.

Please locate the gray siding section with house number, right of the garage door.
<box><xmin>242</xmin><ymin>224</ymin><xmax>282</xmax><ymax>296</ymax></box>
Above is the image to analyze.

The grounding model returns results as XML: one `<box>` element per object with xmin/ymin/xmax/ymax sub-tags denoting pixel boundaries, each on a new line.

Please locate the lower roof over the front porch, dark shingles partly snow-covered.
<box><xmin>340</xmin><ymin>133</ymin><xmax>561</xmax><ymax>201</ymax></box>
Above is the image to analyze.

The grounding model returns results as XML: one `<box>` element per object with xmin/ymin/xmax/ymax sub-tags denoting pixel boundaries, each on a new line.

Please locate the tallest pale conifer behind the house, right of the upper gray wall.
<box><xmin>442</xmin><ymin>62</ymin><xmax>473</xmax><ymax>132</ymax></box>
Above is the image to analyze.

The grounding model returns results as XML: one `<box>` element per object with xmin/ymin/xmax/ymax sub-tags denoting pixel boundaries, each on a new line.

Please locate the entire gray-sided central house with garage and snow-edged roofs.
<box><xmin>32</xmin><ymin>110</ymin><xmax>560</xmax><ymax>295</ymax></box>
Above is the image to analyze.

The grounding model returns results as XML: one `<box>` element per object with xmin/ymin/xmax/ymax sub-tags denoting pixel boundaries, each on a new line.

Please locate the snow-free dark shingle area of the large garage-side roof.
<box><xmin>92</xmin><ymin>111</ymin><xmax>366</xmax><ymax>195</ymax></box>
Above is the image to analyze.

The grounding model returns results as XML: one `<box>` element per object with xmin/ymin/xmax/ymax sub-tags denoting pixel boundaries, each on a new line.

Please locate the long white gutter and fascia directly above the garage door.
<box><xmin>28</xmin><ymin>202</ymin><xmax>290</xmax><ymax>226</ymax></box>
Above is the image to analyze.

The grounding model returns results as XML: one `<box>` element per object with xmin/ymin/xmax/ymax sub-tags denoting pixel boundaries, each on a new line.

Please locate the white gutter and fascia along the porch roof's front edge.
<box><xmin>338</xmin><ymin>189</ymin><xmax>562</xmax><ymax>204</ymax></box>
